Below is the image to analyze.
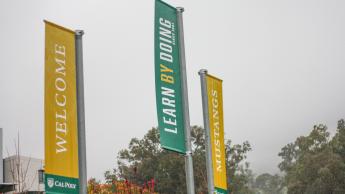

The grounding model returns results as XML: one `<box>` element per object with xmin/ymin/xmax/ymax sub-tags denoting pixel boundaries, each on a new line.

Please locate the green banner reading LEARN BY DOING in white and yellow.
<box><xmin>155</xmin><ymin>0</ymin><xmax>186</xmax><ymax>153</ymax></box>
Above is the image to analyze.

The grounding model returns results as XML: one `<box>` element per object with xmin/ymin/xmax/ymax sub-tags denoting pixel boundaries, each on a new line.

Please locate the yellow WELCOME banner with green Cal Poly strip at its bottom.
<box><xmin>44</xmin><ymin>21</ymin><xmax>79</xmax><ymax>194</ymax></box>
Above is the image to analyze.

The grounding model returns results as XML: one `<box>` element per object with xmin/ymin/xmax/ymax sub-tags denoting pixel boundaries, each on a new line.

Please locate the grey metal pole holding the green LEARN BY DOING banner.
<box><xmin>176</xmin><ymin>7</ymin><xmax>195</xmax><ymax>194</ymax></box>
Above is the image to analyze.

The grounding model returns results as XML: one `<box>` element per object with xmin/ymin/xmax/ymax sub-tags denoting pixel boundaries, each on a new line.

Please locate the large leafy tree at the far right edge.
<box><xmin>279</xmin><ymin>119</ymin><xmax>345</xmax><ymax>194</ymax></box>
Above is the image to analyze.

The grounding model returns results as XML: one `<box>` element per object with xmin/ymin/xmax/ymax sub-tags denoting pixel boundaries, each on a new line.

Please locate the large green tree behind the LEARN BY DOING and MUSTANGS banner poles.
<box><xmin>117</xmin><ymin>126</ymin><xmax>252</xmax><ymax>194</ymax></box>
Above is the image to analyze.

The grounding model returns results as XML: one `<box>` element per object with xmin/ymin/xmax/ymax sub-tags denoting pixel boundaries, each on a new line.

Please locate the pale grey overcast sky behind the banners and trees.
<box><xmin>0</xmin><ymin>0</ymin><xmax>345</xmax><ymax>178</ymax></box>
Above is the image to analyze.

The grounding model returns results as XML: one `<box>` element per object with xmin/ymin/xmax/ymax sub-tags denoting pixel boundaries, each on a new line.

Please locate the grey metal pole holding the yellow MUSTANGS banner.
<box><xmin>199</xmin><ymin>69</ymin><xmax>214</xmax><ymax>194</ymax></box>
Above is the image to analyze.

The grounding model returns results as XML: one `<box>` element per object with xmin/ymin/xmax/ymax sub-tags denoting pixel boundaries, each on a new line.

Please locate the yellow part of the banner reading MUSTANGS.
<box><xmin>206</xmin><ymin>75</ymin><xmax>227</xmax><ymax>190</ymax></box>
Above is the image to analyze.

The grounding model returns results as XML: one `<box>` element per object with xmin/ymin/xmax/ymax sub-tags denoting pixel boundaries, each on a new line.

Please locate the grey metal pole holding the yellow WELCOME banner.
<box><xmin>75</xmin><ymin>30</ymin><xmax>87</xmax><ymax>194</ymax></box>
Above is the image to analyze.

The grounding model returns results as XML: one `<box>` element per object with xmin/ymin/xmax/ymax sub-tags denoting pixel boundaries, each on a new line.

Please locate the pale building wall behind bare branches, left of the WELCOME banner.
<box><xmin>4</xmin><ymin>156</ymin><xmax>44</xmax><ymax>191</ymax></box>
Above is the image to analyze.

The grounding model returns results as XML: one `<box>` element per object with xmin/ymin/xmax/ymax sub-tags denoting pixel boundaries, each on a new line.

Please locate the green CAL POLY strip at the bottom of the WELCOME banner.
<box><xmin>44</xmin><ymin>174</ymin><xmax>79</xmax><ymax>194</ymax></box>
